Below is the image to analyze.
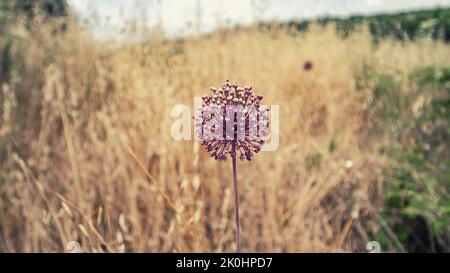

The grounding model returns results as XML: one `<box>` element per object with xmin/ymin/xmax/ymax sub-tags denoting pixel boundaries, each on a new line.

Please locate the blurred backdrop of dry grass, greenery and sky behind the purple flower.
<box><xmin>0</xmin><ymin>0</ymin><xmax>450</xmax><ymax>252</ymax></box>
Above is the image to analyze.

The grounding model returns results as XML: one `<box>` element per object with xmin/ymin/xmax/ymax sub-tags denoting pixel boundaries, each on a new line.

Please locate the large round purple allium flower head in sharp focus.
<box><xmin>195</xmin><ymin>81</ymin><xmax>269</xmax><ymax>161</ymax></box>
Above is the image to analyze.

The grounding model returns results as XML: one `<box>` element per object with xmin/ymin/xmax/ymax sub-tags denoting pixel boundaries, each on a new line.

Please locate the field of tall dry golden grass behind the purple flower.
<box><xmin>0</xmin><ymin>7</ymin><xmax>450</xmax><ymax>252</ymax></box>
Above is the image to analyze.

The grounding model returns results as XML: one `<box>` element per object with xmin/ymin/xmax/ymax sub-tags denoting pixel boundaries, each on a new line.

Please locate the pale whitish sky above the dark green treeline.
<box><xmin>67</xmin><ymin>0</ymin><xmax>450</xmax><ymax>37</ymax></box>
